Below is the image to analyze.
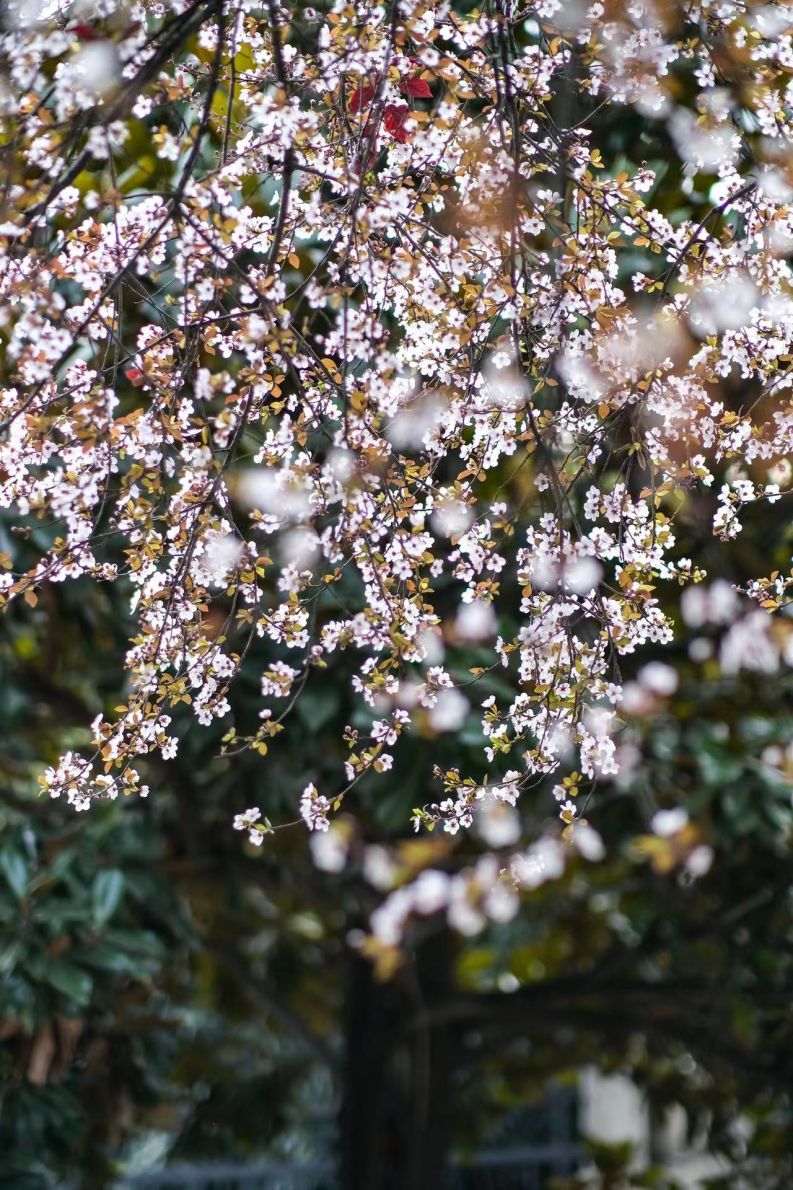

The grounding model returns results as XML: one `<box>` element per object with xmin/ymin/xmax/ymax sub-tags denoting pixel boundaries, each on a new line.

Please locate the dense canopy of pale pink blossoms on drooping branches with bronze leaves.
<box><xmin>0</xmin><ymin>0</ymin><xmax>793</xmax><ymax>938</ymax></box>
